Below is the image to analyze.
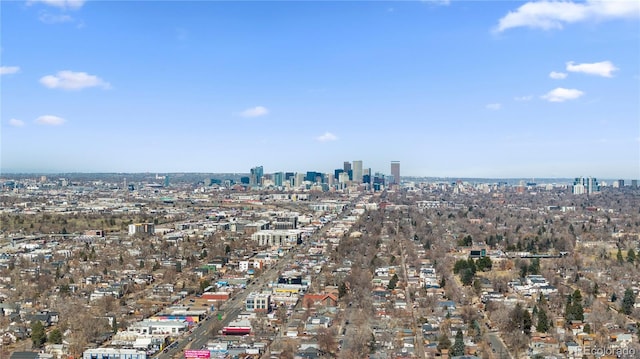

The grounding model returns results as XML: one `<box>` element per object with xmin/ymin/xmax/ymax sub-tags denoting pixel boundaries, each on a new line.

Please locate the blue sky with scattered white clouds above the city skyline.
<box><xmin>0</xmin><ymin>0</ymin><xmax>640</xmax><ymax>179</ymax></box>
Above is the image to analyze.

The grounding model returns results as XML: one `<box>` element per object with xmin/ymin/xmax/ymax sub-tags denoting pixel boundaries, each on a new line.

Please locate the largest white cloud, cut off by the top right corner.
<box><xmin>495</xmin><ymin>0</ymin><xmax>640</xmax><ymax>32</ymax></box>
